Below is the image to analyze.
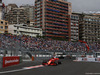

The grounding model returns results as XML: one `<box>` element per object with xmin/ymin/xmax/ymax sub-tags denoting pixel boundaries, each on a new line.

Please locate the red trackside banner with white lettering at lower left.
<box><xmin>3</xmin><ymin>56</ymin><xmax>19</xmax><ymax>67</ymax></box>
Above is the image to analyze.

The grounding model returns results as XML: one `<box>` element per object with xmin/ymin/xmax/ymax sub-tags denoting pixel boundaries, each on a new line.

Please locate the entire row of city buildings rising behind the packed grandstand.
<box><xmin>0</xmin><ymin>0</ymin><xmax>100</xmax><ymax>43</ymax></box>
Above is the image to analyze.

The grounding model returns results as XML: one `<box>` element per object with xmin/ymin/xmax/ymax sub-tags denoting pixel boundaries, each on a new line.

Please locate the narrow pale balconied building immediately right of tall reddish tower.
<box><xmin>71</xmin><ymin>13</ymin><xmax>79</xmax><ymax>41</ymax></box>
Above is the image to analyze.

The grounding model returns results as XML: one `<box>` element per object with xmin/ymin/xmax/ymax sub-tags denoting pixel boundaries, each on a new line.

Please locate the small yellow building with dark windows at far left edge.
<box><xmin>0</xmin><ymin>20</ymin><xmax>8</xmax><ymax>33</ymax></box>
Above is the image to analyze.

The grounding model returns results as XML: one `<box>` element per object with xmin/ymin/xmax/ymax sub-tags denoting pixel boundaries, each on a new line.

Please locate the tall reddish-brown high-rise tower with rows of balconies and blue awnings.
<box><xmin>35</xmin><ymin>0</ymin><xmax>71</xmax><ymax>40</ymax></box>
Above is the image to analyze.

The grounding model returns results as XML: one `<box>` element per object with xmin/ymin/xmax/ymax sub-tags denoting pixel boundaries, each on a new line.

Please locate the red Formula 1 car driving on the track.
<box><xmin>42</xmin><ymin>58</ymin><xmax>61</xmax><ymax>66</ymax></box>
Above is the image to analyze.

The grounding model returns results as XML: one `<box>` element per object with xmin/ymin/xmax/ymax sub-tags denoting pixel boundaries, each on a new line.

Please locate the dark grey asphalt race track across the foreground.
<box><xmin>0</xmin><ymin>59</ymin><xmax>100</xmax><ymax>75</ymax></box>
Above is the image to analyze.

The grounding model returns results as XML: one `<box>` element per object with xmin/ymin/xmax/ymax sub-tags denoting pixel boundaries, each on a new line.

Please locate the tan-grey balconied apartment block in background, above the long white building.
<box><xmin>5</xmin><ymin>8</ymin><xmax>28</xmax><ymax>24</ymax></box>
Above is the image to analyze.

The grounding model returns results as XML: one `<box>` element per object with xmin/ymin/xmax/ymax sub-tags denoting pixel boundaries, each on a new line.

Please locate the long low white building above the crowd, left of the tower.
<box><xmin>8</xmin><ymin>24</ymin><xmax>42</xmax><ymax>37</ymax></box>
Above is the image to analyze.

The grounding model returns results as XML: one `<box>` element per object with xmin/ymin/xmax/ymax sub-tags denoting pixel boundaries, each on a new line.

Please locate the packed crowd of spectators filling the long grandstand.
<box><xmin>0</xmin><ymin>34</ymin><xmax>100</xmax><ymax>52</ymax></box>
